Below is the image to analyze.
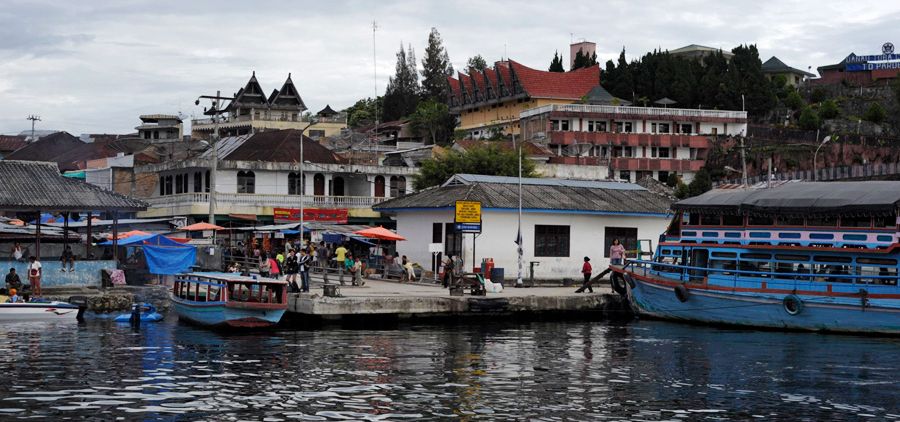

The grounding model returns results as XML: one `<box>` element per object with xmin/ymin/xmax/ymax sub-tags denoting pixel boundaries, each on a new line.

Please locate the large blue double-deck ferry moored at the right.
<box><xmin>611</xmin><ymin>182</ymin><xmax>900</xmax><ymax>334</ymax></box>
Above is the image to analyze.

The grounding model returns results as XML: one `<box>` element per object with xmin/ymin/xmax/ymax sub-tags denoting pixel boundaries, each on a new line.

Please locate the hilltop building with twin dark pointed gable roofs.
<box><xmin>191</xmin><ymin>72</ymin><xmax>347</xmax><ymax>139</ymax></box>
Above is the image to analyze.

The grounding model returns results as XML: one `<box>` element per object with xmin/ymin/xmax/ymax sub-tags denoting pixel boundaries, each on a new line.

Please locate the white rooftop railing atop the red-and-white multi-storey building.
<box><xmin>519</xmin><ymin>104</ymin><xmax>747</xmax><ymax>120</ymax></box>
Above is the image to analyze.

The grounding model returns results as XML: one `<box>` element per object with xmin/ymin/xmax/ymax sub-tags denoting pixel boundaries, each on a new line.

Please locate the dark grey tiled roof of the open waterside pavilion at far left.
<box><xmin>0</xmin><ymin>160</ymin><xmax>147</xmax><ymax>211</ymax></box>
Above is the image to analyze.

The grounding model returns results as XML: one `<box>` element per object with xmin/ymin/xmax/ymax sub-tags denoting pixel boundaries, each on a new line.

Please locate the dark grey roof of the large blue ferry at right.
<box><xmin>672</xmin><ymin>181</ymin><xmax>900</xmax><ymax>215</ymax></box>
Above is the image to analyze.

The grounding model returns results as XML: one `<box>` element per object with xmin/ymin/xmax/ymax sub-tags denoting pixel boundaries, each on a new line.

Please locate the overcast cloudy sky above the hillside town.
<box><xmin>0</xmin><ymin>0</ymin><xmax>900</xmax><ymax>134</ymax></box>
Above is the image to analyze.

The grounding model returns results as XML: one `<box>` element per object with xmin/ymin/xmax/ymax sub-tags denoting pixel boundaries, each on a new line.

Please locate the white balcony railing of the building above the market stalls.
<box><xmin>145</xmin><ymin>193</ymin><xmax>390</xmax><ymax>208</ymax></box>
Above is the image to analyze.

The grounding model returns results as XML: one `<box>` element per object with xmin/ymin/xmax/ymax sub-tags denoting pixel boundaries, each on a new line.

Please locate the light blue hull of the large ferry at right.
<box><xmin>625</xmin><ymin>272</ymin><xmax>900</xmax><ymax>335</ymax></box>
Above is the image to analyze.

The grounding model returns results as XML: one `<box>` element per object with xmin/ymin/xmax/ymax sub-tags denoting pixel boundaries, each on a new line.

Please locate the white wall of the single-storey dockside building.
<box><xmin>397</xmin><ymin>210</ymin><xmax>669</xmax><ymax>280</ymax></box>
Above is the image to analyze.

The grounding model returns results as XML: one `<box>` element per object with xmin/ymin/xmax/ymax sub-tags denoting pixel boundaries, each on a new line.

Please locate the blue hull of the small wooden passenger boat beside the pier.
<box><xmin>172</xmin><ymin>299</ymin><xmax>286</xmax><ymax>328</ymax></box>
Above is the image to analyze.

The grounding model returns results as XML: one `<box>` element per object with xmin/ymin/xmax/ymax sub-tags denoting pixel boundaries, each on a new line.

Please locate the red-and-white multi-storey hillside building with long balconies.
<box><xmin>520</xmin><ymin>104</ymin><xmax>747</xmax><ymax>182</ymax></box>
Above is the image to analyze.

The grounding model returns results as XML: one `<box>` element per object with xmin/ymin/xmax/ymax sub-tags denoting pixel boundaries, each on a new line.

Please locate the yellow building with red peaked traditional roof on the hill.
<box><xmin>448</xmin><ymin>60</ymin><xmax>600</xmax><ymax>138</ymax></box>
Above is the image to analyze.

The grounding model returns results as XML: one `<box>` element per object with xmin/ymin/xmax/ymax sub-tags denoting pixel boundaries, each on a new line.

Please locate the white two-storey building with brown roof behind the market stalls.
<box><xmin>135</xmin><ymin>129</ymin><xmax>417</xmax><ymax>224</ymax></box>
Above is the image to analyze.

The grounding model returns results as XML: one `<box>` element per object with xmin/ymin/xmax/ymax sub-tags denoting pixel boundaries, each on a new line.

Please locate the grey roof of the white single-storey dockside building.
<box><xmin>372</xmin><ymin>175</ymin><xmax>671</xmax><ymax>215</ymax></box>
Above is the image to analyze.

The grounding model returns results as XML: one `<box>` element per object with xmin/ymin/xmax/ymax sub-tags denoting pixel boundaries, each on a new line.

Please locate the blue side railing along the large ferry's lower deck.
<box><xmin>624</xmin><ymin>259</ymin><xmax>898</xmax><ymax>286</ymax></box>
